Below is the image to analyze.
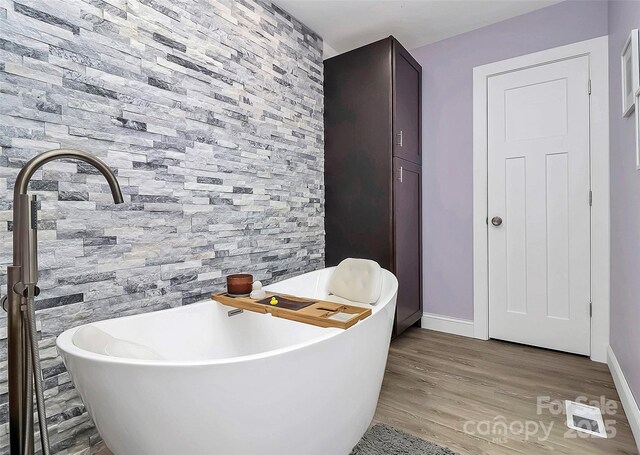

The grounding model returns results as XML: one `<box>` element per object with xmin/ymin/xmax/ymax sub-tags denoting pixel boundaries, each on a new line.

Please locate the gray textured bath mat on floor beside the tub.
<box><xmin>351</xmin><ymin>423</ymin><xmax>457</xmax><ymax>455</ymax></box>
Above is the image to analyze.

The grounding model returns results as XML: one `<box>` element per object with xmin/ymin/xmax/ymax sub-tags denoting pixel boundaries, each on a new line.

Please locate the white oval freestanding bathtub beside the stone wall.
<box><xmin>57</xmin><ymin>268</ymin><xmax>398</xmax><ymax>455</ymax></box>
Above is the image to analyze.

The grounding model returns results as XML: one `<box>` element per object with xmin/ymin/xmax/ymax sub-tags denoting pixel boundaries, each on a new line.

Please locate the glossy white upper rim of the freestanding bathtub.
<box><xmin>56</xmin><ymin>269</ymin><xmax>398</xmax><ymax>368</ymax></box>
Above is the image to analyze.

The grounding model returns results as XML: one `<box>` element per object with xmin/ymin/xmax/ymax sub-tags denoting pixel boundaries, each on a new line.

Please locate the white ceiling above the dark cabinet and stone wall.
<box><xmin>275</xmin><ymin>0</ymin><xmax>561</xmax><ymax>58</ymax></box>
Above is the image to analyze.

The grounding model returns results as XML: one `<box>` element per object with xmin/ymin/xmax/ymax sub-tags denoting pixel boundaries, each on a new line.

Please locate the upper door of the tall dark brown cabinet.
<box><xmin>393</xmin><ymin>44</ymin><xmax>422</xmax><ymax>164</ymax></box>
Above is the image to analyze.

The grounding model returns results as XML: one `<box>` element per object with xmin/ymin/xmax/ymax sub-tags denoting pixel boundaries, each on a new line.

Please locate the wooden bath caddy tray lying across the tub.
<box><xmin>211</xmin><ymin>292</ymin><xmax>371</xmax><ymax>329</ymax></box>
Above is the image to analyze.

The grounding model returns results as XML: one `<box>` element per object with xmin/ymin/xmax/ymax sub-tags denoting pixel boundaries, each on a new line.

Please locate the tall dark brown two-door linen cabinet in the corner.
<box><xmin>324</xmin><ymin>37</ymin><xmax>422</xmax><ymax>336</ymax></box>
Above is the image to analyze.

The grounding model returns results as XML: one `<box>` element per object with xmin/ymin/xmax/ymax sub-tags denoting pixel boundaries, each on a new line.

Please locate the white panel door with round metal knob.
<box><xmin>487</xmin><ymin>56</ymin><xmax>591</xmax><ymax>355</ymax></box>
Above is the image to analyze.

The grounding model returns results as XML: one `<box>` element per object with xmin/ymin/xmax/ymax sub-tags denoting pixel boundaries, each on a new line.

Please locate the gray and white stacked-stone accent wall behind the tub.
<box><xmin>0</xmin><ymin>0</ymin><xmax>324</xmax><ymax>454</ymax></box>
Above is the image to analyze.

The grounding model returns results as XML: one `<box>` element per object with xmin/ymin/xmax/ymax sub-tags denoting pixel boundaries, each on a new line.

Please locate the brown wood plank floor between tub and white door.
<box><xmin>374</xmin><ymin>328</ymin><xmax>638</xmax><ymax>455</ymax></box>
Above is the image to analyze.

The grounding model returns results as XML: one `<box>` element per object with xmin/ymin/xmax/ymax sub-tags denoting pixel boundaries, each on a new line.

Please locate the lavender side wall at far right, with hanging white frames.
<box><xmin>609</xmin><ymin>1</ymin><xmax>640</xmax><ymax>402</ymax></box>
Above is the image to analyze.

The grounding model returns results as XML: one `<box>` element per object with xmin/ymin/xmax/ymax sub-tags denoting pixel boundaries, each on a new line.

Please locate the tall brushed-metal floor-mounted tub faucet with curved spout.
<box><xmin>3</xmin><ymin>149</ymin><xmax>123</xmax><ymax>455</ymax></box>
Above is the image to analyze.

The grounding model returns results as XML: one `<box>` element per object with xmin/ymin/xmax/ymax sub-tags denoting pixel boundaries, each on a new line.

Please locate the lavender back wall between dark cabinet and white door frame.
<box><xmin>411</xmin><ymin>1</ymin><xmax>608</xmax><ymax>319</ymax></box>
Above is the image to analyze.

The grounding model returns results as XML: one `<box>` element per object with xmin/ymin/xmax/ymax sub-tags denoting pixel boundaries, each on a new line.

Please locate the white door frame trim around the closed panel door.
<box><xmin>473</xmin><ymin>36</ymin><xmax>610</xmax><ymax>362</ymax></box>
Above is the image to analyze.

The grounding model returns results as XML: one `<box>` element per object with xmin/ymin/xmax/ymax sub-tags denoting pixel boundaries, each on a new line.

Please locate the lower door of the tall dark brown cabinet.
<box><xmin>393</xmin><ymin>158</ymin><xmax>422</xmax><ymax>336</ymax></box>
